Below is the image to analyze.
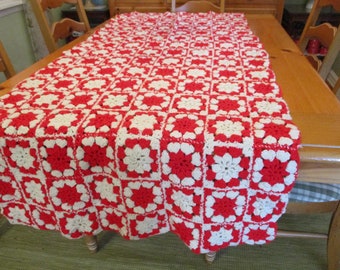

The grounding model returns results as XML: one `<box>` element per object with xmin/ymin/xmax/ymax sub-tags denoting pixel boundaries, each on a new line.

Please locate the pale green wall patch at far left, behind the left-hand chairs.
<box><xmin>0</xmin><ymin>9</ymin><xmax>34</xmax><ymax>82</ymax></box>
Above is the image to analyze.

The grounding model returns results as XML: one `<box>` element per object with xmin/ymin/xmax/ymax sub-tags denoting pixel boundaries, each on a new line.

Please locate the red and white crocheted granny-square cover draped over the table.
<box><xmin>0</xmin><ymin>12</ymin><xmax>300</xmax><ymax>253</ymax></box>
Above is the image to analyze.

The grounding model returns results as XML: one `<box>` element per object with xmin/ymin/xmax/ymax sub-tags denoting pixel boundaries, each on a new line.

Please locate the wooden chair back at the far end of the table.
<box><xmin>172</xmin><ymin>0</ymin><xmax>224</xmax><ymax>13</ymax></box>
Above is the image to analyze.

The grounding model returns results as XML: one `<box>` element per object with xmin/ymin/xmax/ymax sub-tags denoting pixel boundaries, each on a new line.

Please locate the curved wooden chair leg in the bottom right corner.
<box><xmin>327</xmin><ymin>201</ymin><xmax>340</xmax><ymax>270</ymax></box>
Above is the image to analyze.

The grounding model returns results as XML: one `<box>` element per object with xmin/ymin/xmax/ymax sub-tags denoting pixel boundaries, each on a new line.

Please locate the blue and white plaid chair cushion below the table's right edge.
<box><xmin>289</xmin><ymin>181</ymin><xmax>340</xmax><ymax>202</ymax></box>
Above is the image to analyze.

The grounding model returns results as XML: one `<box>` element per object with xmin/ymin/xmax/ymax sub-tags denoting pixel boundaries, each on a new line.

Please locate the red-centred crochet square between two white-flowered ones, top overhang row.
<box><xmin>161</xmin><ymin>143</ymin><xmax>202</xmax><ymax>186</ymax></box>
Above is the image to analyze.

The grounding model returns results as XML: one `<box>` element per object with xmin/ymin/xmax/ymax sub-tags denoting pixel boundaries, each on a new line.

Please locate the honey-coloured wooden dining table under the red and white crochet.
<box><xmin>0</xmin><ymin>14</ymin><xmax>340</xmax><ymax>266</ymax></box>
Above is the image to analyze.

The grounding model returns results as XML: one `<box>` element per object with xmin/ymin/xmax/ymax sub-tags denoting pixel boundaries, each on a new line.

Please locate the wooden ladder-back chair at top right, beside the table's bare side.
<box><xmin>298</xmin><ymin>0</ymin><xmax>340</xmax><ymax>92</ymax></box>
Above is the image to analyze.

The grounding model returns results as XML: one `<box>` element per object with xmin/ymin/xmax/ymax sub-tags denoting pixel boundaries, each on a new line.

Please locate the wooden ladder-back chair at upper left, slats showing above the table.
<box><xmin>30</xmin><ymin>0</ymin><xmax>90</xmax><ymax>53</ymax></box>
